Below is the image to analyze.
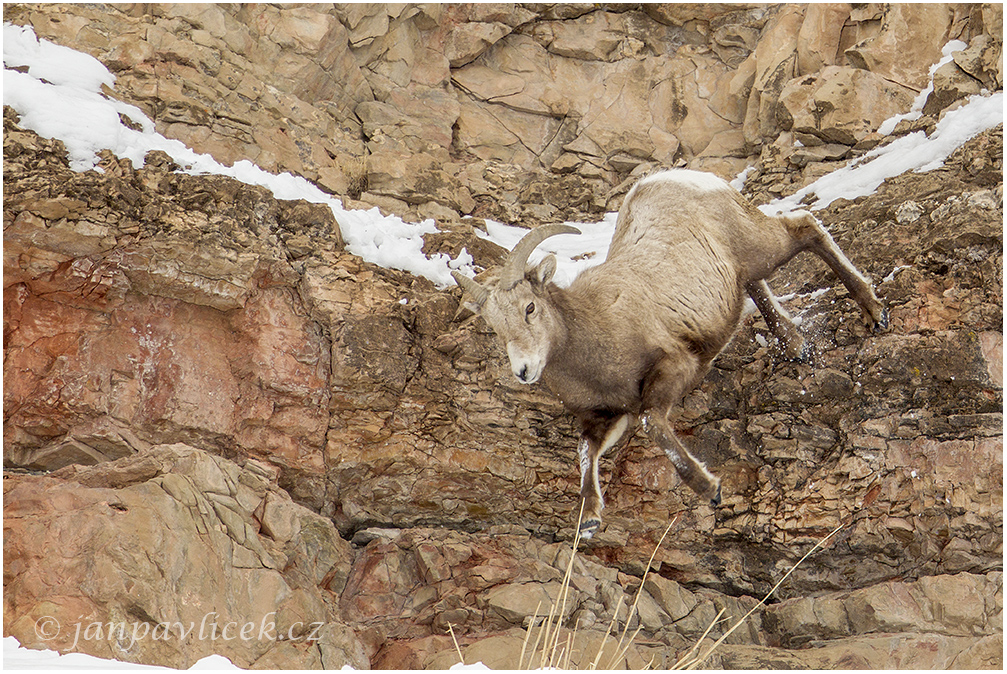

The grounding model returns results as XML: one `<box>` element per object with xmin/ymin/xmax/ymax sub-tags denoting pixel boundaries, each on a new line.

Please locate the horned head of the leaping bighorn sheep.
<box><xmin>452</xmin><ymin>225</ymin><xmax>580</xmax><ymax>384</ymax></box>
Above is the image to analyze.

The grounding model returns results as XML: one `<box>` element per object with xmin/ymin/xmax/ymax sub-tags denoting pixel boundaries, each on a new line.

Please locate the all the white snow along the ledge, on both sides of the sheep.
<box><xmin>3</xmin><ymin>22</ymin><xmax>1003</xmax><ymax>288</ymax></box>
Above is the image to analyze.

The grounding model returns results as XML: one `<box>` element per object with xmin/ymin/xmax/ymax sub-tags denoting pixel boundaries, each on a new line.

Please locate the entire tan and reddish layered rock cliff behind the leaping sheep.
<box><xmin>4</xmin><ymin>4</ymin><xmax>1003</xmax><ymax>668</ymax></box>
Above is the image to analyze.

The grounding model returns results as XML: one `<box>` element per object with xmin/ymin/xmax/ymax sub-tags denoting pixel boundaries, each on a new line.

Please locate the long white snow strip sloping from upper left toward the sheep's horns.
<box><xmin>3</xmin><ymin>23</ymin><xmax>474</xmax><ymax>287</ymax></box>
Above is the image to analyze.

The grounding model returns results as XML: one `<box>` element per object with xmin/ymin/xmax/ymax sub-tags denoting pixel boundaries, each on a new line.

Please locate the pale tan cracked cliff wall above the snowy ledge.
<box><xmin>4</xmin><ymin>3</ymin><xmax>1003</xmax><ymax>224</ymax></box>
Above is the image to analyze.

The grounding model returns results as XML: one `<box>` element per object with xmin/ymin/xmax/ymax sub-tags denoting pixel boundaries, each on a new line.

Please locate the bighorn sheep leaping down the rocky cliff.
<box><xmin>454</xmin><ymin>169</ymin><xmax>888</xmax><ymax>538</ymax></box>
